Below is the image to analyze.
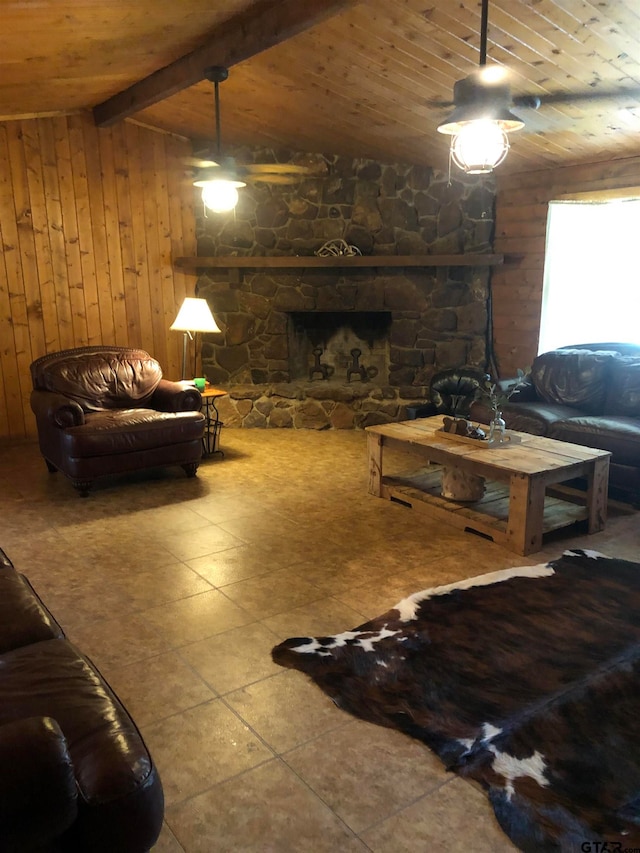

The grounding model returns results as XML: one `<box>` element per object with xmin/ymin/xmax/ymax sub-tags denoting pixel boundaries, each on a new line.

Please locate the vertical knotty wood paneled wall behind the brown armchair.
<box><xmin>0</xmin><ymin>115</ymin><xmax>196</xmax><ymax>438</ymax></box>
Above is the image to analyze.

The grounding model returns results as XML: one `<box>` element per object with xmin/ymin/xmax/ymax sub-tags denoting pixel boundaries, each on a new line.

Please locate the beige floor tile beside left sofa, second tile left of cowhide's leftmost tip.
<box><xmin>108</xmin><ymin>652</ymin><xmax>215</xmax><ymax>725</ymax></box>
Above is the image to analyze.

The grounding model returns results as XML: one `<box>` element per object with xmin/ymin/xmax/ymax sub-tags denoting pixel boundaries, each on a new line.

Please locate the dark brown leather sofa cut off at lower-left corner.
<box><xmin>0</xmin><ymin>550</ymin><xmax>164</xmax><ymax>853</ymax></box>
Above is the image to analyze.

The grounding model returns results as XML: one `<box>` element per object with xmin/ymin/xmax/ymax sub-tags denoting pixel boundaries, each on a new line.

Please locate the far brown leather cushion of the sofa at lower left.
<box><xmin>0</xmin><ymin>568</ymin><xmax>64</xmax><ymax>654</ymax></box>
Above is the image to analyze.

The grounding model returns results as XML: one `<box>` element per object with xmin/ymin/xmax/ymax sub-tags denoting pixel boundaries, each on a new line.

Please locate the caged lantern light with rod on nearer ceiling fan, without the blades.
<box><xmin>438</xmin><ymin>0</ymin><xmax>524</xmax><ymax>175</ymax></box>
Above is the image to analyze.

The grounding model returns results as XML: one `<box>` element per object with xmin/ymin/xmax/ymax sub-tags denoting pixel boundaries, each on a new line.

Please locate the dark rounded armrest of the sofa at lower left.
<box><xmin>0</xmin><ymin>717</ymin><xmax>78</xmax><ymax>853</ymax></box>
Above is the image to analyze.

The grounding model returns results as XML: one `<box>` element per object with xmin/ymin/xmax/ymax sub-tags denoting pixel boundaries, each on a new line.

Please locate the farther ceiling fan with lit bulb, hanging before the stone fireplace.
<box><xmin>190</xmin><ymin>65</ymin><xmax>309</xmax><ymax>211</ymax></box>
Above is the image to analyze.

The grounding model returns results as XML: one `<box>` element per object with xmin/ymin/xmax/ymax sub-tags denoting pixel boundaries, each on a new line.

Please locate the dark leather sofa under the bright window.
<box><xmin>471</xmin><ymin>343</ymin><xmax>640</xmax><ymax>502</ymax></box>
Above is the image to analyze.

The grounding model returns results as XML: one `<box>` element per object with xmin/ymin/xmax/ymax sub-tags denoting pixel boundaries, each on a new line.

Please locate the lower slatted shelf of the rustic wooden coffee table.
<box><xmin>381</xmin><ymin>465</ymin><xmax>589</xmax><ymax>548</ymax></box>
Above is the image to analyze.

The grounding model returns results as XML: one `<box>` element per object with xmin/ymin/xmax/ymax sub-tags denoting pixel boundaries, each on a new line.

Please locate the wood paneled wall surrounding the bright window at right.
<box><xmin>492</xmin><ymin>157</ymin><xmax>640</xmax><ymax>378</ymax></box>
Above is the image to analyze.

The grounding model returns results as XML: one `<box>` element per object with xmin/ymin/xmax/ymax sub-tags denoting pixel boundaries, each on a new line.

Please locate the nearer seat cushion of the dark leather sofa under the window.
<box><xmin>549</xmin><ymin>416</ymin><xmax>640</xmax><ymax>468</ymax></box>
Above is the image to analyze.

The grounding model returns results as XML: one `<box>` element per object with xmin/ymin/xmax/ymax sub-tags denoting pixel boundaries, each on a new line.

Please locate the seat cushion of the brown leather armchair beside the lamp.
<box><xmin>61</xmin><ymin>409</ymin><xmax>204</xmax><ymax>459</ymax></box>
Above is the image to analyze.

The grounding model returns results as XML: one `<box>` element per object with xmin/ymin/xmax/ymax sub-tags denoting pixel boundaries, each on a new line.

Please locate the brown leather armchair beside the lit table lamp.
<box><xmin>31</xmin><ymin>346</ymin><xmax>205</xmax><ymax>497</ymax></box>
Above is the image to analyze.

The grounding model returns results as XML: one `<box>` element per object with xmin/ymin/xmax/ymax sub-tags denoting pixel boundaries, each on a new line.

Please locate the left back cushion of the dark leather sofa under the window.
<box><xmin>531</xmin><ymin>348</ymin><xmax>619</xmax><ymax>415</ymax></box>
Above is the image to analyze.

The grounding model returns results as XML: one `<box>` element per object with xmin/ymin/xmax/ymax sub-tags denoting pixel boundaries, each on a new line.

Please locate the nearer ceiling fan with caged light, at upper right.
<box><xmin>428</xmin><ymin>0</ymin><xmax>640</xmax><ymax>174</ymax></box>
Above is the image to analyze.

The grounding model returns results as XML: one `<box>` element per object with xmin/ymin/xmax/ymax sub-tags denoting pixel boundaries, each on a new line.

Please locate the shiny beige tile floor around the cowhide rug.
<box><xmin>0</xmin><ymin>429</ymin><xmax>639</xmax><ymax>853</ymax></box>
